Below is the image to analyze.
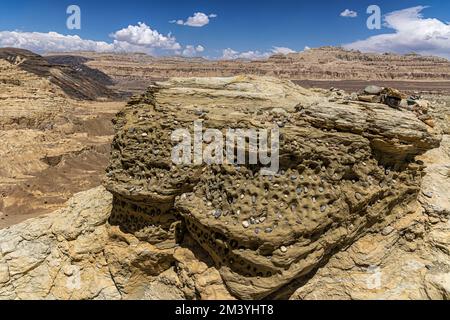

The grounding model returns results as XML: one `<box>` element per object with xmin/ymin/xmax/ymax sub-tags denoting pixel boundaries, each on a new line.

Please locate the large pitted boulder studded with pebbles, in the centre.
<box><xmin>105</xmin><ymin>77</ymin><xmax>440</xmax><ymax>299</ymax></box>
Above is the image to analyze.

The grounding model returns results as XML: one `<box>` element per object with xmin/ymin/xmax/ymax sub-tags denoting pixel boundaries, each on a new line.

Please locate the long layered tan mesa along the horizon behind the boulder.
<box><xmin>44</xmin><ymin>47</ymin><xmax>450</xmax><ymax>93</ymax></box>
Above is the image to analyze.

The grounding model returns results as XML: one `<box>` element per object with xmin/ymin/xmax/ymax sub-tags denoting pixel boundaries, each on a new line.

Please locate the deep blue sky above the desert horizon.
<box><xmin>0</xmin><ymin>0</ymin><xmax>450</xmax><ymax>58</ymax></box>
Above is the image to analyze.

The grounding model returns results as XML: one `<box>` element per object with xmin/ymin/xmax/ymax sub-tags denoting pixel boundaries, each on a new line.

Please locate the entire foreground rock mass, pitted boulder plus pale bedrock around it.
<box><xmin>0</xmin><ymin>76</ymin><xmax>450</xmax><ymax>299</ymax></box>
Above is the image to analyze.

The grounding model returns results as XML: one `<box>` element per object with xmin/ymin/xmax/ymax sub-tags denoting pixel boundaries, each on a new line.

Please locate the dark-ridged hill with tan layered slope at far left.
<box><xmin>0</xmin><ymin>48</ymin><xmax>118</xmax><ymax>130</ymax></box>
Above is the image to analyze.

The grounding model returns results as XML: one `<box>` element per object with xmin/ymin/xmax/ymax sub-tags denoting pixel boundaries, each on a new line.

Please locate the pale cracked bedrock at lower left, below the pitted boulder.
<box><xmin>0</xmin><ymin>187</ymin><xmax>233</xmax><ymax>300</ymax></box>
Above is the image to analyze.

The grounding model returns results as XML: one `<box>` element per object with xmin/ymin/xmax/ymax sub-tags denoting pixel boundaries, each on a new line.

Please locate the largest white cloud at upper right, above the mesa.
<box><xmin>344</xmin><ymin>6</ymin><xmax>450</xmax><ymax>58</ymax></box>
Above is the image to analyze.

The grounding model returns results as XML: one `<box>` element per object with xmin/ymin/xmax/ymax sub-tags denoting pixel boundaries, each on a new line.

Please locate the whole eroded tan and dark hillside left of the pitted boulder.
<box><xmin>0</xmin><ymin>48</ymin><xmax>122</xmax><ymax>228</ymax></box>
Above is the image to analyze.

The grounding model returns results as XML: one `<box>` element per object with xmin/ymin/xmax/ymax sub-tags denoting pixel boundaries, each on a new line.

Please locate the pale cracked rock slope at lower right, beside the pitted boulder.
<box><xmin>286</xmin><ymin>135</ymin><xmax>450</xmax><ymax>300</ymax></box>
